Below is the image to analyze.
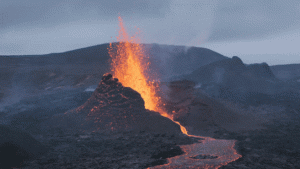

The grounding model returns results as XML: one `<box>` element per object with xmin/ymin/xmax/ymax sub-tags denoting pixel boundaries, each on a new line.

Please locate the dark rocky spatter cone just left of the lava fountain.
<box><xmin>77</xmin><ymin>74</ymin><xmax>180</xmax><ymax>133</ymax></box>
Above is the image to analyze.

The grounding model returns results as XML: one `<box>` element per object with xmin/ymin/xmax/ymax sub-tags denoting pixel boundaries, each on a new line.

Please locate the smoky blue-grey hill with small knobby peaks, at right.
<box><xmin>173</xmin><ymin>56</ymin><xmax>284</xmax><ymax>101</ymax></box>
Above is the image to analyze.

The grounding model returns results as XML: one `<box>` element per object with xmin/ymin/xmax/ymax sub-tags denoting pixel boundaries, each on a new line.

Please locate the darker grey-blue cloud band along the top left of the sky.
<box><xmin>0</xmin><ymin>0</ymin><xmax>170</xmax><ymax>30</ymax></box>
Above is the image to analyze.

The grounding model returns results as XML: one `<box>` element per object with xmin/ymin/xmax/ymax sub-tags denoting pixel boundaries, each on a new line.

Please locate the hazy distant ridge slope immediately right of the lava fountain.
<box><xmin>145</xmin><ymin>44</ymin><xmax>228</xmax><ymax>79</ymax></box>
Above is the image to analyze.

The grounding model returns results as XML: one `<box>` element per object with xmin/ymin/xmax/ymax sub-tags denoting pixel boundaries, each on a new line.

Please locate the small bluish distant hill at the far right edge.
<box><xmin>270</xmin><ymin>64</ymin><xmax>300</xmax><ymax>81</ymax></box>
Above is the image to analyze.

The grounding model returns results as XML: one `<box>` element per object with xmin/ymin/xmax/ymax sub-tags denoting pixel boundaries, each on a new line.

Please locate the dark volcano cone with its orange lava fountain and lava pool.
<box><xmin>39</xmin><ymin>17</ymin><xmax>244</xmax><ymax>168</ymax></box>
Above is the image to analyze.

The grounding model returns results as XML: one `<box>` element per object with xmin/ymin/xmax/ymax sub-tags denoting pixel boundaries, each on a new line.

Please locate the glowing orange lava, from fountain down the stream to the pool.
<box><xmin>109</xmin><ymin>17</ymin><xmax>241</xmax><ymax>169</ymax></box>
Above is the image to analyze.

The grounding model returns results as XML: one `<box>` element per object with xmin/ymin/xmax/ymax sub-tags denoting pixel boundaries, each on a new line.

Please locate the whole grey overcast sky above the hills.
<box><xmin>0</xmin><ymin>0</ymin><xmax>300</xmax><ymax>65</ymax></box>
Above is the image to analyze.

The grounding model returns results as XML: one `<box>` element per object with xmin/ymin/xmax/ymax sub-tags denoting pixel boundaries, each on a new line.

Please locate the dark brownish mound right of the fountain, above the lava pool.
<box><xmin>164</xmin><ymin>80</ymin><xmax>258</xmax><ymax>136</ymax></box>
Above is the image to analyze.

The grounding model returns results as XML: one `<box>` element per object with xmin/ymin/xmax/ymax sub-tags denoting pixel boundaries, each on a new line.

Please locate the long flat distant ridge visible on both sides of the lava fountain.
<box><xmin>0</xmin><ymin>44</ymin><xmax>227</xmax><ymax>73</ymax></box>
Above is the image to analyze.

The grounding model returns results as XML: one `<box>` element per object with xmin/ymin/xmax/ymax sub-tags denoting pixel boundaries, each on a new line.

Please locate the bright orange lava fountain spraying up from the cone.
<box><xmin>109</xmin><ymin>17</ymin><xmax>160</xmax><ymax>115</ymax></box>
